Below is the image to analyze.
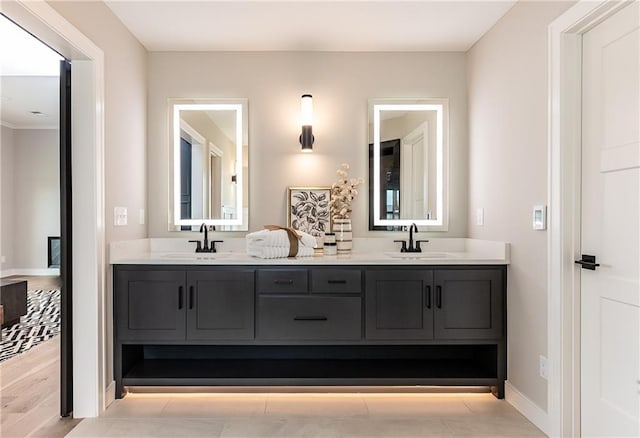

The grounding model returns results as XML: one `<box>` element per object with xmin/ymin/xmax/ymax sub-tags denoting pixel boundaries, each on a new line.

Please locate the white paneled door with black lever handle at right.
<box><xmin>581</xmin><ymin>2</ymin><xmax>640</xmax><ymax>437</ymax></box>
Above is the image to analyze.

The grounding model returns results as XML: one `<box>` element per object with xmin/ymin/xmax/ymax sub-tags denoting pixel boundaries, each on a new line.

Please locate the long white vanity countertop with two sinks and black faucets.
<box><xmin>109</xmin><ymin>237</ymin><xmax>509</xmax><ymax>266</ymax></box>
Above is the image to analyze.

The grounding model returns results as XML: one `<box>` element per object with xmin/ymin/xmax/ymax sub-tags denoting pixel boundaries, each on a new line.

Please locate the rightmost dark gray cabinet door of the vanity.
<box><xmin>434</xmin><ymin>269</ymin><xmax>504</xmax><ymax>339</ymax></box>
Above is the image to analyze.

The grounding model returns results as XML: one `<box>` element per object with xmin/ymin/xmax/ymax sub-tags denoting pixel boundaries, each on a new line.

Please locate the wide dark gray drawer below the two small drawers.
<box><xmin>257</xmin><ymin>296</ymin><xmax>361</xmax><ymax>341</ymax></box>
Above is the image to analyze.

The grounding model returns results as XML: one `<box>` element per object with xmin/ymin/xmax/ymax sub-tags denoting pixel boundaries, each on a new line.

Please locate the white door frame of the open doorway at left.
<box><xmin>0</xmin><ymin>0</ymin><xmax>105</xmax><ymax>418</ymax></box>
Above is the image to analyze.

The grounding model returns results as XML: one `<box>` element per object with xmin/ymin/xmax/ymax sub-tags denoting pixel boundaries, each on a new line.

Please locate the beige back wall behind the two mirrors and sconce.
<box><xmin>148</xmin><ymin>52</ymin><xmax>468</xmax><ymax>237</ymax></box>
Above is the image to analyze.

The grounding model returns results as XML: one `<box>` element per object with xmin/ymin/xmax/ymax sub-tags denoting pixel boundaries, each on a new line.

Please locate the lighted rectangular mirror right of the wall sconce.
<box><xmin>369</xmin><ymin>99</ymin><xmax>449</xmax><ymax>231</ymax></box>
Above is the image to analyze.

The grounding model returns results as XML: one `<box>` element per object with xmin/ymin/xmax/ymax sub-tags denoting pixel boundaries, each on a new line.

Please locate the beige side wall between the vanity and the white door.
<box><xmin>468</xmin><ymin>2</ymin><xmax>571</xmax><ymax>410</ymax></box>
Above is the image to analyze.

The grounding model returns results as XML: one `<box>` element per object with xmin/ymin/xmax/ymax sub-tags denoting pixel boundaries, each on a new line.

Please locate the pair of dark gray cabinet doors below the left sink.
<box><xmin>115</xmin><ymin>268</ymin><xmax>254</xmax><ymax>342</ymax></box>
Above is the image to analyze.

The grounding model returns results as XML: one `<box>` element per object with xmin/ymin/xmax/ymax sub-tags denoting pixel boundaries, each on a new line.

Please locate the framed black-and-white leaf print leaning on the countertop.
<box><xmin>287</xmin><ymin>186</ymin><xmax>331</xmax><ymax>237</ymax></box>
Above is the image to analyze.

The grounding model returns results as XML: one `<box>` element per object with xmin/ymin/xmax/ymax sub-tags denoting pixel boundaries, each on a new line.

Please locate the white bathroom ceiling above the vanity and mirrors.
<box><xmin>105</xmin><ymin>0</ymin><xmax>517</xmax><ymax>51</ymax></box>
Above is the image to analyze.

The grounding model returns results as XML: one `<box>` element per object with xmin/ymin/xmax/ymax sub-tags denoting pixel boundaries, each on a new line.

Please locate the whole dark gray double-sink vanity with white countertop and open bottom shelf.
<box><xmin>112</xmin><ymin>238</ymin><xmax>508</xmax><ymax>398</ymax></box>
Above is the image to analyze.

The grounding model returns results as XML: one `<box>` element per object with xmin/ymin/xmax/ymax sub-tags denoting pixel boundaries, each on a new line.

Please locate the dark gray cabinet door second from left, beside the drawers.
<box><xmin>187</xmin><ymin>271</ymin><xmax>254</xmax><ymax>340</ymax></box>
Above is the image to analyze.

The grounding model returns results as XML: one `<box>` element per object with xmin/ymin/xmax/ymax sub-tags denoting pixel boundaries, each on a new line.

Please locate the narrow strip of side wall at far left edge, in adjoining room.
<box><xmin>0</xmin><ymin>126</ymin><xmax>15</xmax><ymax>271</ymax></box>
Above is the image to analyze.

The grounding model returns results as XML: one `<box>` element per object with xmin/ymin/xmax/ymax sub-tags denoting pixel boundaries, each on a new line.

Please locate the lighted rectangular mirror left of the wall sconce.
<box><xmin>169</xmin><ymin>99</ymin><xmax>248</xmax><ymax>231</ymax></box>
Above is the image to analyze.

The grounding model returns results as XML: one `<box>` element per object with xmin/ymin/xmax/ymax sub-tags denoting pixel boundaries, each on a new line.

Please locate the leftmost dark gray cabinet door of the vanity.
<box><xmin>115</xmin><ymin>270</ymin><xmax>186</xmax><ymax>341</ymax></box>
